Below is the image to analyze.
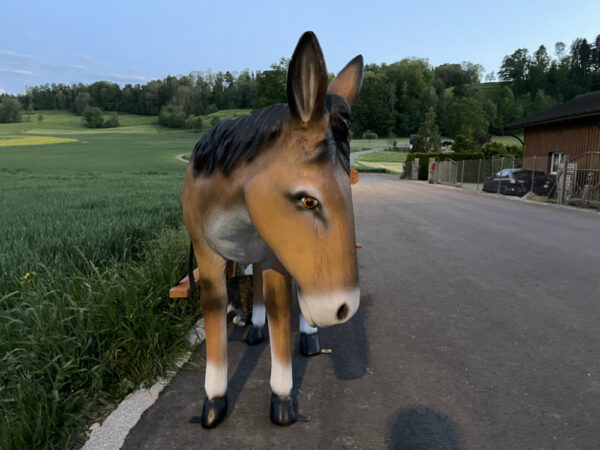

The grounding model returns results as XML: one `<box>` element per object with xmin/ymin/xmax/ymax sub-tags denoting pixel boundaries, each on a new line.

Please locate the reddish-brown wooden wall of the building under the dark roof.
<box><xmin>523</xmin><ymin>117</ymin><xmax>600</xmax><ymax>160</ymax></box>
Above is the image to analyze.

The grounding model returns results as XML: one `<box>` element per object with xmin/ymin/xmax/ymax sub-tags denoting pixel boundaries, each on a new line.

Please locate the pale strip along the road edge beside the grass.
<box><xmin>82</xmin><ymin>316</ymin><xmax>204</xmax><ymax>450</ymax></box>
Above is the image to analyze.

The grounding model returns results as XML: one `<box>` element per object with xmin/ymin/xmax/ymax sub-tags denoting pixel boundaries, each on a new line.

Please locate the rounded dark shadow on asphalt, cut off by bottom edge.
<box><xmin>386</xmin><ymin>406</ymin><xmax>461</xmax><ymax>450</ymax></box>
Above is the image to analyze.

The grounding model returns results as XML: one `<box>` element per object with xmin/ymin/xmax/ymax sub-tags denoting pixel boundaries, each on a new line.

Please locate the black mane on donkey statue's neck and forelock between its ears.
<box><xmin>191</xmin><ymin>95</ymin><xmax>350</xmax><ymax>176</ymax></box>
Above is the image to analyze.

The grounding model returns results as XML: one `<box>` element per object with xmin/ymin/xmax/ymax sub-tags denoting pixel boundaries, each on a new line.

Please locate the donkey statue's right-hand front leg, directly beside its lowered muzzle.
<box><xmin>263</xmin><ymin>265</ymin><xmax>298</xmax><ymax>425</ymax></box>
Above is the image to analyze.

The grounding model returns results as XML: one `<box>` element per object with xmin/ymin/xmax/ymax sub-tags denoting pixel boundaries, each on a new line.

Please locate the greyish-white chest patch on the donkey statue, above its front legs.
<box><xmin>206</xmin><ymin>208</ymin><xmax>272</xmax><ymax>264</ymax></box>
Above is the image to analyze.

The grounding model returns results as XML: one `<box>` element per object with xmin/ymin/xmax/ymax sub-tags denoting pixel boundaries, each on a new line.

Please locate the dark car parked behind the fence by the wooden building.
<box><xmin>482</xmin><ymin>169</ymin><xmax>551</xmax><ymax>197</ymax></box>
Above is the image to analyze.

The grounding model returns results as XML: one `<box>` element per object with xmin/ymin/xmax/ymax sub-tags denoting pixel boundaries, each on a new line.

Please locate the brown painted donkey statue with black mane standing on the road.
<box><xmin>182</xmin><ymin>32</ymin><xmax>363</xmax><ymax>428</ymax></box>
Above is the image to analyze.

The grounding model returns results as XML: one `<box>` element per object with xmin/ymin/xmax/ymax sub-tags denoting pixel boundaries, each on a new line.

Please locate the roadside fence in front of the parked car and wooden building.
<box><xmin>406</xmin><ymin>152</ymin><xmax>600</xmax><ymax>208</ymax></box>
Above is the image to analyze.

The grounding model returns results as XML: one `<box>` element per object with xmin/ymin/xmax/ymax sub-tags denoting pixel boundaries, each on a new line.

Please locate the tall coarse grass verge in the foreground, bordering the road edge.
<box><xmin>0</xmin><ymin>230</ymin><xmax>199</xmax><ymax>449</ymax></box>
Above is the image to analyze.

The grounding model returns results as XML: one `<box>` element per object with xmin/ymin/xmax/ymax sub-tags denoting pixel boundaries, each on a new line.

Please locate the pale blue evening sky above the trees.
<box><xmin>0</xmin><ymin>0</ymin><xmax>600</xmax><ymax>94</ymax></box>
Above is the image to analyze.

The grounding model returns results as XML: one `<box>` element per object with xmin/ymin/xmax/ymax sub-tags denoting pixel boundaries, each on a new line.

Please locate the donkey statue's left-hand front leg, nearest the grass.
<box><xmin>192</xmin><ymin>242</ymin><xmax>227</xmax><ymax>428</ymax></box>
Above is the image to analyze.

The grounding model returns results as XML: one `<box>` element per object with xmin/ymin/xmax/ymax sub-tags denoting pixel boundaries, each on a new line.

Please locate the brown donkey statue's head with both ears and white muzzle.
<box><xmin>245</xmin><ymin>32</ymin><xmax>363</xmax><ymax>327</ymax></box>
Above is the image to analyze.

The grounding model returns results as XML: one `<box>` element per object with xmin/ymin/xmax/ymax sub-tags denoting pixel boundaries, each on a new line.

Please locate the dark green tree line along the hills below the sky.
<box><xmin>0</xmin><ymin>35</ymin><xmax>600</xmax><ymax>142</ymax></box>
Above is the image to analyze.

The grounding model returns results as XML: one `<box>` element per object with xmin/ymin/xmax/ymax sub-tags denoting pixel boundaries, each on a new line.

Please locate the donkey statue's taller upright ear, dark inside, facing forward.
<box><xmin>287</xmin><ymin>31</ymin><xmax>327</xmax><ymax>123</ymax></box>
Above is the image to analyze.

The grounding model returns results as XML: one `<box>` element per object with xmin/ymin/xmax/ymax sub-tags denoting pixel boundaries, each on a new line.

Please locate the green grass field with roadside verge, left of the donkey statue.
<box><xmin>0</xmin><ymin>111</ymin><xmax>206</xmax><ymax>449</ymax></box>
